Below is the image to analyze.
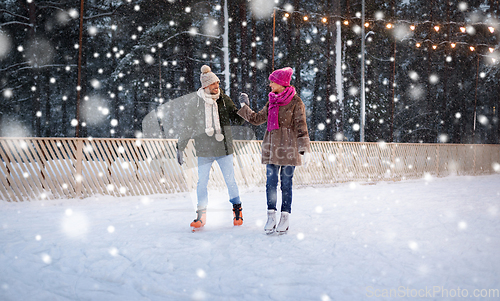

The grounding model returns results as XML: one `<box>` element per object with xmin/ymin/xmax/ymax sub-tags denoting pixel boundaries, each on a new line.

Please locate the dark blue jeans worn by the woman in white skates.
<box><xmin>266</xmin><ymin>164</ymin><xmax>295</xmax><ymax>213</ymax></box>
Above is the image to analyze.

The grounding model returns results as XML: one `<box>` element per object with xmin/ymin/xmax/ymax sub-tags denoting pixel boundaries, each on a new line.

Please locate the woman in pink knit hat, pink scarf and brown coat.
<box><xmin>238</xmin><ymin>67</ymin><xmax>311</xmax><ymax>234</ymax></box>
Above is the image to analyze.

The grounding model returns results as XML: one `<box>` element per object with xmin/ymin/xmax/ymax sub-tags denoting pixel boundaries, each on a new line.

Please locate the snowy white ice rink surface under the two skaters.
<box><xmin>0</xmin><ymin>175</ymin><xmax>500</xmax><ymax>301</ymax></box>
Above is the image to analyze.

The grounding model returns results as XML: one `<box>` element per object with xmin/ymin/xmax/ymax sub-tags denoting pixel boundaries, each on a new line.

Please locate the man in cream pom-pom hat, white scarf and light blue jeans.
<box><xmin>177</xmin><ymin>65</ymin><xmax>245</xmax><ymax>230</ymax></box>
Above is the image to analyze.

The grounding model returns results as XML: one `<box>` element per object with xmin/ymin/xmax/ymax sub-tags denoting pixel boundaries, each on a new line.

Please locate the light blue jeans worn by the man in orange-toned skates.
<box><xmin>196</xmin><ymin>154</ymin><xmax>241</xmax><ymax>209</ymax></box>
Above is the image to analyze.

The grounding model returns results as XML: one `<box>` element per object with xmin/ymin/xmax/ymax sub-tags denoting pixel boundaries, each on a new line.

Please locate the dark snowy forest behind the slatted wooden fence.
<box><xmin>0</xmin><ymin>0</ymin><xmax>500</xmax><ymax>143</ymax></box>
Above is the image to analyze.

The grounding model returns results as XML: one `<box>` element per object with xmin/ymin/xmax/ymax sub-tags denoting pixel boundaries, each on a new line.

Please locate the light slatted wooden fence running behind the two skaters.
<box><xmin>0</xmin><ymin>138</ymin><xmax>500</xmax><ymax>201</ymax></box>
